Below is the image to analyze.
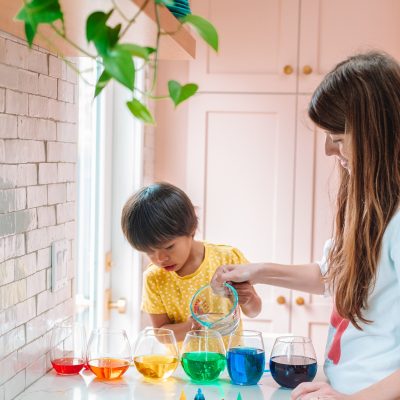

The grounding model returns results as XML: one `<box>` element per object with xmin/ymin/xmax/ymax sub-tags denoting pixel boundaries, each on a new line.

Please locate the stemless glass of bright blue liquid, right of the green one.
<box><xmin>226</xmin><ymin>330</ymin><xmax>265</xmax><ymax>385</ymax></box>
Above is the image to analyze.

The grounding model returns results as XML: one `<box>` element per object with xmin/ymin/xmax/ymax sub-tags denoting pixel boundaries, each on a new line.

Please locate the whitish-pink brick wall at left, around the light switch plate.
<box><xmin>0</xmin><ymin>28</ymin><xmax>78</xmax><ymax>400</ymax></box>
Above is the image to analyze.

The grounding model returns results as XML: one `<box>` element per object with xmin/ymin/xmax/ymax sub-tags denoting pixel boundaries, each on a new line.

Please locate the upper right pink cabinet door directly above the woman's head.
<box><xmin>299</xmin><ymin>0</ymin><xmax>400</xmax><ymax>93</ymax></box>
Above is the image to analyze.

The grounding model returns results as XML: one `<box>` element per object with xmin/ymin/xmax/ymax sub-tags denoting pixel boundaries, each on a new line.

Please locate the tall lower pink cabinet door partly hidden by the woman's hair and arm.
<box><xmin>291</xmin><ymin>95</ymin><xmax>338</xmax><ymax>363</ymax></box>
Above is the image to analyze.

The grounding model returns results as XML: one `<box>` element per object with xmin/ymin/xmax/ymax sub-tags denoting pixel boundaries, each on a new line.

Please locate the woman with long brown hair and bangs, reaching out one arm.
<box><xmin>212</xmin><ymin>52</ymin><xmax>400</xmax><ymax>400</ymax></box>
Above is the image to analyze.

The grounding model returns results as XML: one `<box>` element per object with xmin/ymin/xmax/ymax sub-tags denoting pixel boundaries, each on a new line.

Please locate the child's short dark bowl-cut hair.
<box><xmin>121</xmin><ymin>182</ymin><xmax>198</xmax><ymax>251</ymax></box>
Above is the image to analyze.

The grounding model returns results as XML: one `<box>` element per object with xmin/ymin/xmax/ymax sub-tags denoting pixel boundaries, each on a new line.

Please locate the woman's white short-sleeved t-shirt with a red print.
<box><xmin>319</xmin><ymin>212</ymin><xmax>400</xmax><ymax>394</ymax></box>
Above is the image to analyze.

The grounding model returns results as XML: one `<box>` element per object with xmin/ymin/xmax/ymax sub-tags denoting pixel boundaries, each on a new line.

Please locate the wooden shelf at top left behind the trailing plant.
<box><xmin>0</xmin><ymin>0</ymin><xmax>196</xmax><ymax>60</ymax></box>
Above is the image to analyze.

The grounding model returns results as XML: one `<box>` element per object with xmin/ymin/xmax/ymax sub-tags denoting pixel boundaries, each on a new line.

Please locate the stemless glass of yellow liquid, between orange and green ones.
<box><xmin>133</xmin><ymin>328</ymin><xmax>179</xmax><ymax>381</ymax></box>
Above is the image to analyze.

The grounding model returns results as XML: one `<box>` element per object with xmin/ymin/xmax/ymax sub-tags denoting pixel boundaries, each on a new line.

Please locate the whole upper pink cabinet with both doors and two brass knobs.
<box><xmin>190</xmin><ymin>0</ymin><xmax>400</xmax><ymax>93</ymax></box>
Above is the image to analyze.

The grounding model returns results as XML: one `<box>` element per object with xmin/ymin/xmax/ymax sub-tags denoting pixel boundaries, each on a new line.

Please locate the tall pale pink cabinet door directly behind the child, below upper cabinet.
<box><xmin>186</xmin><ymin>94</ymin><xmax>296</xmax><ymax>332</ymax></box>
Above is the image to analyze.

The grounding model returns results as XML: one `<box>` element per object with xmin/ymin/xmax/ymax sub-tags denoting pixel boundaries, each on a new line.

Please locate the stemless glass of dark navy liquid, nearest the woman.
<box><xmin>269</xmin><ymin>336</ymin><xmax>317</xmax><ymax>389</ymax></box>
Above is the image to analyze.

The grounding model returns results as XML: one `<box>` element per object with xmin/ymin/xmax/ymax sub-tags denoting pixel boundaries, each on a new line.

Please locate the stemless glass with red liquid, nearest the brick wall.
<box><xmin>50</xmin><ymin>320</ymin><xmax>86</xmax><ymax>375</ymax></box>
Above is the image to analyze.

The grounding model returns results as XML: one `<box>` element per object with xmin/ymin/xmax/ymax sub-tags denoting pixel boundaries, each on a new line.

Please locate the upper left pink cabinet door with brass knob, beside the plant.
<box><xmin>190</xmin><ymin>0</ymin><xmax>299</xmax><ymax>93</ymax></box>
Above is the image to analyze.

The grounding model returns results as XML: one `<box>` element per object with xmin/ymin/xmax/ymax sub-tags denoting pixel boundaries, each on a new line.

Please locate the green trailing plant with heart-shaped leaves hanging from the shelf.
<box><xmin>16</xmin><ymin>0</ymin><xmax>218</xmax><ymax>124</ymax></box>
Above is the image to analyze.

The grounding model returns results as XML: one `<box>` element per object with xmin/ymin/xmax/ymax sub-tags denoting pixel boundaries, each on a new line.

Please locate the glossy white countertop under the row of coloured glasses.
<box><xmin>16</xmin><ymin>367</ymin><xmax>304</xmax><ymax>400</ymax></box>
